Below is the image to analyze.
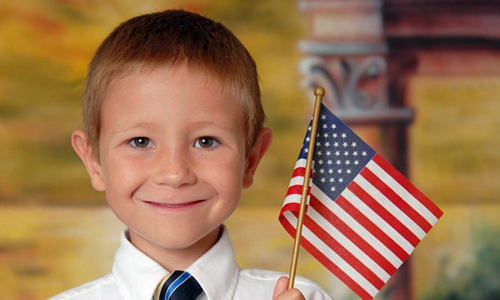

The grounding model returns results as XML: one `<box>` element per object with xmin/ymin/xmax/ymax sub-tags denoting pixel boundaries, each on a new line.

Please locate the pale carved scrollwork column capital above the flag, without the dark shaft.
<box><xmin>298</xmin><ymin>0</ymin><xmax>413</xmax><ymax>123</ymax></box>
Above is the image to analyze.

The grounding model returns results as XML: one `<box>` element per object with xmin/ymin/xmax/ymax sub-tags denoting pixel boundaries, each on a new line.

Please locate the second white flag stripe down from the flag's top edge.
<box><xmin>354</xmin><ymin>174</ymin><xmax>426</xmax><ymax>240</ymax></box>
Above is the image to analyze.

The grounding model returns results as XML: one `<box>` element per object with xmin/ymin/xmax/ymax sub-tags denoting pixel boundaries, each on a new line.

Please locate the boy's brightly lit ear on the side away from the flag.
<box><xmin>71</xmin><ymin>130</ymin><xmax>105</xmax><ymax>192</ymax></box>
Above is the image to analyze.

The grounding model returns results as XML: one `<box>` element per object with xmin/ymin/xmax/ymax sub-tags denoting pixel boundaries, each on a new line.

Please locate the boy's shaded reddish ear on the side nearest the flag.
<box><xmin>243</xmin><ymin>127</ymin><xmax>273</xmax><ymax>189</ymax></box>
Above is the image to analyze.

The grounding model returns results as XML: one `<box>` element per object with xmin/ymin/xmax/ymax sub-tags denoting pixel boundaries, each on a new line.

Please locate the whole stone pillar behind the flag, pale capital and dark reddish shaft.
<box><xmin>298</xmin><ymin>0</ymin><xmax>413</xmax><ymax>300</ymax></box>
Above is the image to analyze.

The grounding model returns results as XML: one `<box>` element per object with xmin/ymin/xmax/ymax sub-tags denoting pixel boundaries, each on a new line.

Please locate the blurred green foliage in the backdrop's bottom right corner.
<box><xmin>424</xmin><ymin>229</ymin><xmax>500</xmax><ymax>300</ymax></box>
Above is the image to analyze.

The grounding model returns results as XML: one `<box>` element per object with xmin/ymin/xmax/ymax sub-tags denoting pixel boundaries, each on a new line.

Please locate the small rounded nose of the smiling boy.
<box><xmin>154</xmin><ymin>150</ymin><xmax>196</xmax><ymax>188</ymax></box>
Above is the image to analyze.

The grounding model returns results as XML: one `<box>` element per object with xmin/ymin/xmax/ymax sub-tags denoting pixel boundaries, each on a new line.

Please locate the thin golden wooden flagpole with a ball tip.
<box><xmin>288</xmin><ymin>87</ymin><xmax>325</xmax><ymax>289</ymax></box>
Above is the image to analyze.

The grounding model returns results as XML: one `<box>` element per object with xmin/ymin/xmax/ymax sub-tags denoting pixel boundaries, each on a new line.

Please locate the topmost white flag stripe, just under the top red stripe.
<box><xmin>366</xmin><ymin>160</ymin><xmax>438</xmax><ymax>225</ymax></box>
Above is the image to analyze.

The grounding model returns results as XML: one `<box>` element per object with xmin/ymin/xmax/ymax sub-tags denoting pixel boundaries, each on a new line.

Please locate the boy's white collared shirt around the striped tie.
<box><xmin>48</xmin><ymin>228</ymin><xmax>331</xmax><ymax>300</ymax></box>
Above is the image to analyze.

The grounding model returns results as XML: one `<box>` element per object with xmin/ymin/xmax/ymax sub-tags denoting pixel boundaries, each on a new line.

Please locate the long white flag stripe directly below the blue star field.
<box><xmin>313</xmin><ymin>186</ymin><xmax>403</xmax><ymax>268</ymax></box>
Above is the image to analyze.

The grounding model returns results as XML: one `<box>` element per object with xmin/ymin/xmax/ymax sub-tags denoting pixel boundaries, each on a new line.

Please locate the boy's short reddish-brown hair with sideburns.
<box><xmin>82</xmin><ymin>10</ymin><xmax>265</xmax><ymax>157</ymax></box>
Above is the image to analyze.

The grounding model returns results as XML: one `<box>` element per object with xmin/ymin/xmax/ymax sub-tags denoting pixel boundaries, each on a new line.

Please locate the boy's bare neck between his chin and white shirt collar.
<box><xmin>129</xmin><ymin>225</ymin><xmax>222</xmax><ymax>272</ymax></box>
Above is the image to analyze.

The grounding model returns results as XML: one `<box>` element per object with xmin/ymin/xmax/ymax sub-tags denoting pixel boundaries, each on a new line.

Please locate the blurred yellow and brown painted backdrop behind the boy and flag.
<box><xmin>0</xmin><ymin>0</ymin><xmax>500</xmax><ymax>300</ymax></box>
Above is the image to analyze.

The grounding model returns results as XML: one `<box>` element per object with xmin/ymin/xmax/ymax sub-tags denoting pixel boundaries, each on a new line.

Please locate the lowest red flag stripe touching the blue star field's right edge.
<box><xmin>335</xmin><ymin>196</ymin><xmax>410</xmax><ymax>261</ymax></box>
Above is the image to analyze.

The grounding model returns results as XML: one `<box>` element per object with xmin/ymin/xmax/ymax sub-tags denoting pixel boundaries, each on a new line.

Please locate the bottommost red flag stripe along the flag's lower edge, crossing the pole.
<box><xmin>279</xmin><ymin>215</ymin><xmax>373</xmax><ymax>300</ymax></box>
